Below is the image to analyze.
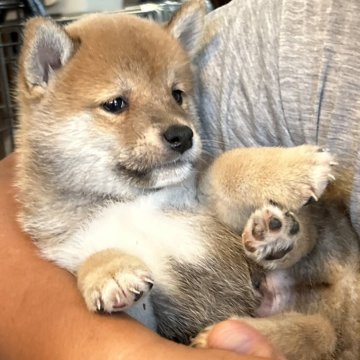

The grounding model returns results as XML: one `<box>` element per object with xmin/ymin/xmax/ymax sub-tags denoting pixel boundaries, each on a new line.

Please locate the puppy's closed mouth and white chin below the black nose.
<box><xmin>117</xmin><ymin>159</ymin><xmax>194</xmax><ymax>188</ymax></box>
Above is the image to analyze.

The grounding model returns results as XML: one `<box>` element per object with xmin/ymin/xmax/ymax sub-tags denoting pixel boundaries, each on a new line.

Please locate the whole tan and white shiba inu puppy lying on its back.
<box><xmin>17</xmin><ymin>1</ymin><xmax>358</xmax><ymax>359</ymax></box>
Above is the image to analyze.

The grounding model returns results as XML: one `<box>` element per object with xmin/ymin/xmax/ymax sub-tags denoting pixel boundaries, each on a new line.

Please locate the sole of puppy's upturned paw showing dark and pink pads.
<box><xmin>242</xmin><ymin>205</ymin><xmax>302</xmax><ymax>269</ymax></box>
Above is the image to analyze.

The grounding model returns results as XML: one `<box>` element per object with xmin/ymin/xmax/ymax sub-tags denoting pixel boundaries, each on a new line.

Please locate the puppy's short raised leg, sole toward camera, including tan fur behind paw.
<box><xmin>242</xmin><ymin>205</ymin><xmax>316</xmax><ymax>270</ymax></box>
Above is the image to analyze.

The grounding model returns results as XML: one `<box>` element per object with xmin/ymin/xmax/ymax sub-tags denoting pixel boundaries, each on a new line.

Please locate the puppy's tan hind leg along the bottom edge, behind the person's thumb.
<box><xmin>192</xmin><ymin>312</ymin><xmax>336</xmax><ymax>360</ymax></box>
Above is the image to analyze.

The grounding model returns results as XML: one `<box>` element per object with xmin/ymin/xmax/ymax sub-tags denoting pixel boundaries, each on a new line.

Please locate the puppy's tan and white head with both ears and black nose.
<box><xmin>17</xmin><ymin>0</ymin><xmax>204</xmax><ymax>196</ymax></box>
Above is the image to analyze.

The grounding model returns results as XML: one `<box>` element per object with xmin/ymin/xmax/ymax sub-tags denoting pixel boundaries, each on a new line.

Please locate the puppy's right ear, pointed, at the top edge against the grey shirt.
<box><xmin>167</xmin><ymin>0</ymin><xmax>206</xmax><ymax>57</ymax></box>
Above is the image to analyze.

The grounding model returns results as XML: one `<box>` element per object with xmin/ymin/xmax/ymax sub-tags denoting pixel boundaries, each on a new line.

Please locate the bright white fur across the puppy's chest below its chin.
<box><xmin>43</xmin><ymin>188</ymin><xmax>206</xmax><ymax>329</ymax></box>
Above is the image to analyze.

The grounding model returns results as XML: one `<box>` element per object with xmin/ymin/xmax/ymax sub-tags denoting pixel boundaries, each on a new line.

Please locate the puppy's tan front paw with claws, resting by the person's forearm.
<box><xmin>78</xmin><ymin>249</ymin><xmax>154</xmax><ymax>313</ymax></box>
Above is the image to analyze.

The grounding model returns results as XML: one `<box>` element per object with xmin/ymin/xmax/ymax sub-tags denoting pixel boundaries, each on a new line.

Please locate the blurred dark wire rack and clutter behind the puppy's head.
<box><xmin>0</xmin><ymin>0</ymin><xmax>228</xmax><ymax>159</ymax></box>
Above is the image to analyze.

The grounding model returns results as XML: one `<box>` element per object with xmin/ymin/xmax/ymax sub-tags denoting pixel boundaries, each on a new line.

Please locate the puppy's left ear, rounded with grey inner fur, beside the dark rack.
<box><xmin>20</xmin><ymin>17</ymin><xmax>74</xmax><ymax>89</ymax></box>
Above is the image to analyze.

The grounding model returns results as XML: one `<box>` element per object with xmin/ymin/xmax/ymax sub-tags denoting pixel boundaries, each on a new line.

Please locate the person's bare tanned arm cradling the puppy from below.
<box><xmin>0</xmin><ymin>155</ymin><xmax>282</xmax><ymax>360</ymax></box>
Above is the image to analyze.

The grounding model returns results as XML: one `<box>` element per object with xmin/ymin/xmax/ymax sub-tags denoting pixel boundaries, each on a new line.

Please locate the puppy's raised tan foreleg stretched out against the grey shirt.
<box><xmin>200</xmin><ymin>145</ymin><xmax>336</xmax><ymax>231</ymax></box>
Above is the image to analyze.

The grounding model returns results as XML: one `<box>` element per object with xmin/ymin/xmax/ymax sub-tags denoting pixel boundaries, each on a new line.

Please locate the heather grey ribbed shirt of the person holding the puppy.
<box><xmin>197</xmin><ymin>0</ymin><xmax>360</xmax><ymax>234</ymax></box>
